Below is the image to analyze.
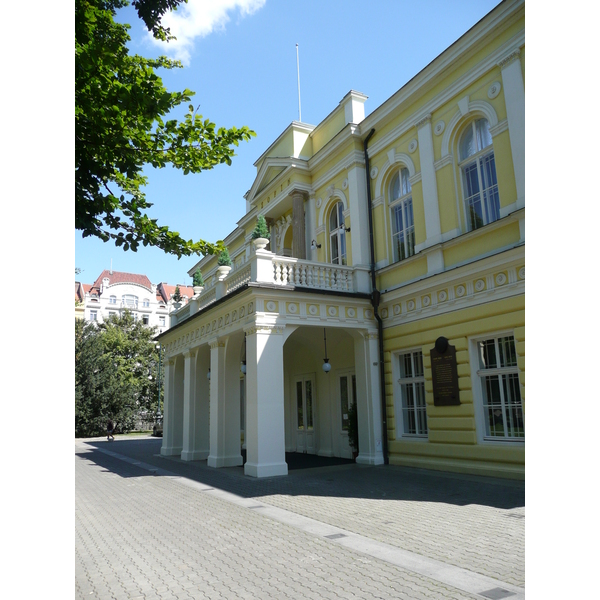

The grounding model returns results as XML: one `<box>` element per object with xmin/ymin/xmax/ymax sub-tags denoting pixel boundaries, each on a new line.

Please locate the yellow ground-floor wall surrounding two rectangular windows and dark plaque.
<box><xmin>384</xmin><ymin>296</ymin><xmax>525</xmax><ymax>478</ymax></box>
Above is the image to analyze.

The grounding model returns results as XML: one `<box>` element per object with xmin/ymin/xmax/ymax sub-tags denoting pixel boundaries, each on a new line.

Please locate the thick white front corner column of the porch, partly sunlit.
<box><xmin>244</xmin><ymin>325</ymin><xmax>288</xmax><ymax>477</ymax></box>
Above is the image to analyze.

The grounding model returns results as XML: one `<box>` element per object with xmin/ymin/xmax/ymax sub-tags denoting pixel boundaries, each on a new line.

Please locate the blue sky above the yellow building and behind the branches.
<box><xmin>75</xmin><ymin>0</ymin><xmax>499</xmax><ymax>284</ymax></box>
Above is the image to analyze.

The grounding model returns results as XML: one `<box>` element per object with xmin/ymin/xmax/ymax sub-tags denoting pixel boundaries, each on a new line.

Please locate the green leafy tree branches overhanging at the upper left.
<box><xmin>75</xmin><ymin>0</ymin><xmax>255</xmax><ymax>258</ymax></box>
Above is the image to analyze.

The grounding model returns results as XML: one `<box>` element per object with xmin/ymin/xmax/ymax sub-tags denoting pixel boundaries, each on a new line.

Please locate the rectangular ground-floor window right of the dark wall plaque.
<box><xmin>476</xmin><ymin>335</ymin><xmax>525</xmax><ymax>440</ymax></box>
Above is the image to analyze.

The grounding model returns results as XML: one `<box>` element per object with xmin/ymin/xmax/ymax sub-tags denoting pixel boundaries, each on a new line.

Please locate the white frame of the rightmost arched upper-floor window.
<box><xmin>456</xmin><ymin>117</ymin><xmax>500</xmax><ymax>231</ymax></box>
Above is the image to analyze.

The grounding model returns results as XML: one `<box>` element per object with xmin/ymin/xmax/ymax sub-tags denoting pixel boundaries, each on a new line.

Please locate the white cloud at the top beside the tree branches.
<box><xmin>152</xmin><ymin>0</ymin><xmax>266</xmax><ymax>64</ymax></box>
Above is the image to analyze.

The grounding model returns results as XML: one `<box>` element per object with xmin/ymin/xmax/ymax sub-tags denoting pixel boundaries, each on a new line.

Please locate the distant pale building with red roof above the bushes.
<box><xmin>75</xmin><ymin>269</ymin><xmax>194</xmax><ymax>333</ymax></box>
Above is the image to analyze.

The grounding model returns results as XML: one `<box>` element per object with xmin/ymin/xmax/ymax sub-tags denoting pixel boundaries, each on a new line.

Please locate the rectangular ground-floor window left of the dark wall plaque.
<box><xmin>398</xmin><ymin>350</ymin><xmax>428</xmax><ymax>437</ymax></box>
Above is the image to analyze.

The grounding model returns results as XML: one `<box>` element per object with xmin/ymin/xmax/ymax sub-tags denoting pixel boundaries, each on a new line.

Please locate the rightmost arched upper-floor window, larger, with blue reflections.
<box><xmin>458</xmin><ymin>119</ymin><xmax>500</xmax><ymax>230</ymax></box>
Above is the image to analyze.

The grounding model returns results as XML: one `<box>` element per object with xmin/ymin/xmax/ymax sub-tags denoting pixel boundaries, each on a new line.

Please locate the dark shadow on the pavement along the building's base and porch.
<box><xmin>76</xmin><ymin>438</ymin><xmax>525</xmax><ymax>509</ymax></box>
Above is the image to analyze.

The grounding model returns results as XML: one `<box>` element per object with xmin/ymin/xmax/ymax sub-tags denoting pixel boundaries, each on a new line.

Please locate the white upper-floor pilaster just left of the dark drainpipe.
<box><xmin>348</xmin><ymin>164</ymin><xmax>371</xmax><ymax>293</ymax></box>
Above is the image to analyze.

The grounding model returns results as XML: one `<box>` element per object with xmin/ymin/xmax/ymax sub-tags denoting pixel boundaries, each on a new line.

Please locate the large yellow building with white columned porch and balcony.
<box><xmin>160</xmin><ymin>0</ymin><xmax>525</xmax><ymax>478</ymax></box>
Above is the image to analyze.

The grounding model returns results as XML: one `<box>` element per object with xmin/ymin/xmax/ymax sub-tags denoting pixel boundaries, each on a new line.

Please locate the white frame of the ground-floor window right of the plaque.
<box><xmin>469</xmin><ymin>330</ymin><xmax>525</xmax><ymax>446</ymax></box>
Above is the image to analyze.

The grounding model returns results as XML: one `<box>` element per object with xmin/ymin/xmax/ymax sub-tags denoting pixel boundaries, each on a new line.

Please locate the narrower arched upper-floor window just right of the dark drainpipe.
<box><xmin>390</xmin><ymin>168</ymin><xmax>415</xmax><ymax>261</ymax></box>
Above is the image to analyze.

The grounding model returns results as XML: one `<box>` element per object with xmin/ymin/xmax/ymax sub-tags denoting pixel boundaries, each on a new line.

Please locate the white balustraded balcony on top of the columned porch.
<box><xmin>171</xmin><ymin>250</ymin><xmax>371</xmax><ymax>327</ymax></box>
